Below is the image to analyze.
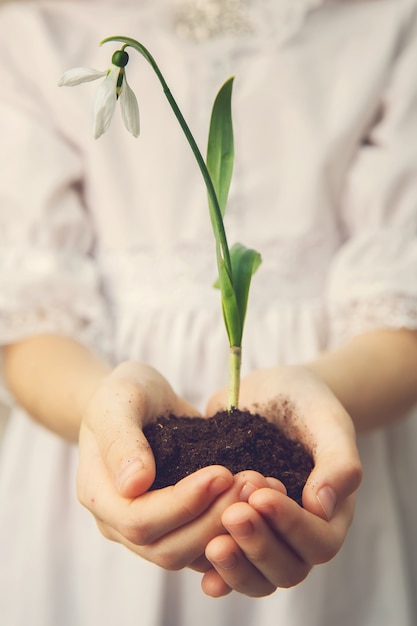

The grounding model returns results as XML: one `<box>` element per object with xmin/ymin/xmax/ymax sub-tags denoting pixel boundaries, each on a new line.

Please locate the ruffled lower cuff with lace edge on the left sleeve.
<box><xmin>0</xmin><ymin>245</ymin><xmax>109</xmax><ymax>349</ymax></box>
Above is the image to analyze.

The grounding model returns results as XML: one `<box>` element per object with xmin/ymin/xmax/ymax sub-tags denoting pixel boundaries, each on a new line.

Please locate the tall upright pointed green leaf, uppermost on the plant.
<box><xmin>206</xmin><ymin>77</ymin><xmax>234</xmax><ymax>216</ymax></box>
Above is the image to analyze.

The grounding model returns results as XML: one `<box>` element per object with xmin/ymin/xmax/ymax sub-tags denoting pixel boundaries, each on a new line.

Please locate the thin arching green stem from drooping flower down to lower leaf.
<box><xmin>100</xmin><ymin>35</ymin><xmax>232</xmax><ymax>280</ymax></box>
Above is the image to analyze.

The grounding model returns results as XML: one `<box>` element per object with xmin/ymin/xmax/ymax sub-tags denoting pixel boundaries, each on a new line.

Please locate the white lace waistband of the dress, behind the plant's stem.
<box><xmin>98</xmin><ymin>239</ymin><xmax>330</xmax><ymax>315</ymax></box>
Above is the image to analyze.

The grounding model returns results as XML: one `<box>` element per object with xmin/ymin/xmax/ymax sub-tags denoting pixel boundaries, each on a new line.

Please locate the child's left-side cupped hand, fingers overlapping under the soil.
<box><xmin>77</xmin><ymin>362</ymin><xmax>240</xmax><ymax>571</ymax></box>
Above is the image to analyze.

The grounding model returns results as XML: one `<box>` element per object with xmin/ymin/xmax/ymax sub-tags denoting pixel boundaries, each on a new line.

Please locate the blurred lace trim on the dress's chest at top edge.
<box><xmin>174</xmin><ymin>0</ymin><xmax>323</xmax><ymax>44</ymax></box>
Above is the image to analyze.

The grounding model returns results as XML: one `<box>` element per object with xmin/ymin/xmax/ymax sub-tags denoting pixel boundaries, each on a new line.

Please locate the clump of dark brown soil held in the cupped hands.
<box><xmin>144</xmin><ymin>409</ymin><xmax>314</xmax><ymax>505</ymax></box>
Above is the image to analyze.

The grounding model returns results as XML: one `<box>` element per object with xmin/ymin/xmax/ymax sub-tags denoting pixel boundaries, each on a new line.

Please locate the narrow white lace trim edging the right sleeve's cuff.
<box><xmin>330</xmin><ymin>294</ymin><xmax>417</xmax><ymax>345</ymax></box>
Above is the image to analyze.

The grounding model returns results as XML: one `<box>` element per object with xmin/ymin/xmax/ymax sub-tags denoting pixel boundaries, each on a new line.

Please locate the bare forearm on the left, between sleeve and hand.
<box><xmin>4</xmin><ymin>335</ymin><xmax>110</xmax><ymax>441</ymax></box>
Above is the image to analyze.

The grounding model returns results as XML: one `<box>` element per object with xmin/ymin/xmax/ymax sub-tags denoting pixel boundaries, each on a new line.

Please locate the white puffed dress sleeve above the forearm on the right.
<box><xmin>327</xmin><ymin>4</ymin><xmax>417</xmax><ymax>345</ymax></box>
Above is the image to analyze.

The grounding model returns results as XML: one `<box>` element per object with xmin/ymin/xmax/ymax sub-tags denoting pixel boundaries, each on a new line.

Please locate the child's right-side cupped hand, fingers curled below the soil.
<box><xmin>203</xmin><ymin>367</ymin><xmax>361</xmax><ymax>596</ymax></box>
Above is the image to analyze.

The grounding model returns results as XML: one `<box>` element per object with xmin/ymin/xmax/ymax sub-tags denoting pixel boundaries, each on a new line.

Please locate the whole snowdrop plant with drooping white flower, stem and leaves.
<box><xmin>58</xmin><ymin>36</ymin><xmax>261</xmax><ymax>412</ymax></box>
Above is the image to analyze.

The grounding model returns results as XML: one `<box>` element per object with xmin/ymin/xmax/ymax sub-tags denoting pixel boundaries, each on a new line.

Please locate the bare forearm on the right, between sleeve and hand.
<box><xmin>308</xmin><ymin>330</ymin><xmax>417</xmax><ymax>432</ymax></box>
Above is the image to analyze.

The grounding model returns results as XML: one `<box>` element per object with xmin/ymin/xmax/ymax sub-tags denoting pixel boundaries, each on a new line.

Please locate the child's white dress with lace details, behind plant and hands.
<box><xmin>0</xmin><ymin>0</ymin><xmax>417</xmax><ymax>626</ymax></box>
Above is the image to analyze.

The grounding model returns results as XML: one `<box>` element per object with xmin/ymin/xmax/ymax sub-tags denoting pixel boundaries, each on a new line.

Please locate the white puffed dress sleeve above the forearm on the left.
<box><xmin>0</xmin><ymin>8</ymin><xmax>109</xmax><ymax>400</ymax></box>
